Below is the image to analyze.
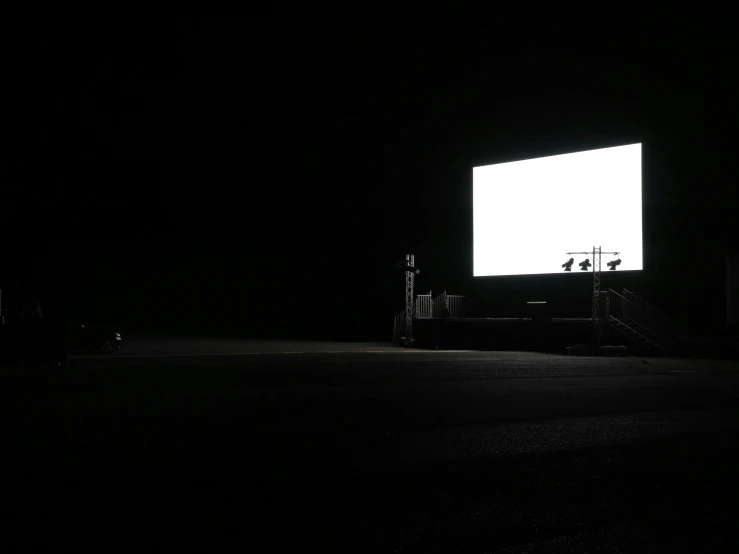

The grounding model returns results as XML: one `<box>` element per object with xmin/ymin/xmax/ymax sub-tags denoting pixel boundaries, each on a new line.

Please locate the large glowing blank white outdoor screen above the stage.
<box><xmin>472</xmin><ymin>144</ymin><xmax>642</xmax><ymax>277</ymax></box>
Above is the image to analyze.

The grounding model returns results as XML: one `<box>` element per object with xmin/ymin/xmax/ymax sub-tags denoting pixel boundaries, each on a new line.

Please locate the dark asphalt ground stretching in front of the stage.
<box><xmin>0</xmin><ymin>339</ymin><xmax>739</xmax><ymax>553</ymax></box>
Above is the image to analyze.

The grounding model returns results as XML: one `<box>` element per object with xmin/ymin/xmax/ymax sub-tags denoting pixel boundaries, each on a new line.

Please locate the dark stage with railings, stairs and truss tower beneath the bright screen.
<box><xmin>393</xmin><ymin>251</ymin><xmax>680</xmax><ymax>355</ymax></box>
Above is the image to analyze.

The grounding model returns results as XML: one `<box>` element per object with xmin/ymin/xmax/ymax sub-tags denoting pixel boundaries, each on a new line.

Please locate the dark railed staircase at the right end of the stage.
<box><xmin>604</xmin><ymin>289</ymin><xmax>677</xmax><ymax>354</ymax></box>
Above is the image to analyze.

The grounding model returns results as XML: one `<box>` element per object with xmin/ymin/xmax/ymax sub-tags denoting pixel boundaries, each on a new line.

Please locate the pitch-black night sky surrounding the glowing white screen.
<box><xmin>1</xmin><ymin>18</ymin><xmax>739</xmax><ymax>339</ymax></box>
